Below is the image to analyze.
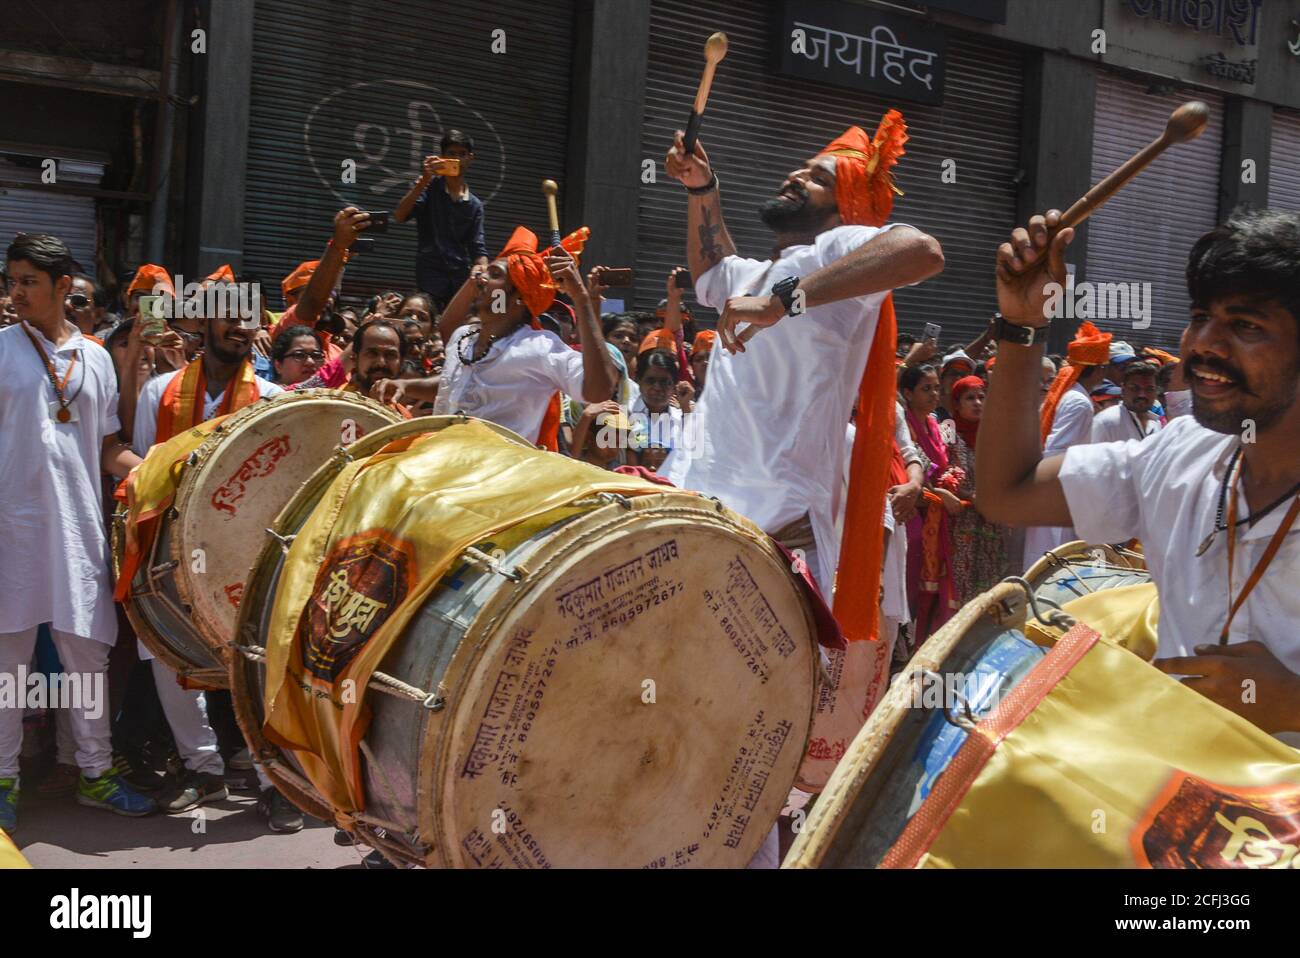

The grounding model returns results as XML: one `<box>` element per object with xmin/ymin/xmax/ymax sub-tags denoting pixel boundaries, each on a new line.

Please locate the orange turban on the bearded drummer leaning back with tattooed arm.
<box><xmin>818</xmin><ymin>109</ymin><xmax>907</xmax><ymax>226</ymax></box>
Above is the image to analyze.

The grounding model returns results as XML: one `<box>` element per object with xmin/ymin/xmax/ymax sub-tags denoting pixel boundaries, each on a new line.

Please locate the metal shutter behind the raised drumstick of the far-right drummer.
<box><xmin>1083</xmin><ymin>73</ymin><xmax>1223</xmax><ymax>348</ymax></box>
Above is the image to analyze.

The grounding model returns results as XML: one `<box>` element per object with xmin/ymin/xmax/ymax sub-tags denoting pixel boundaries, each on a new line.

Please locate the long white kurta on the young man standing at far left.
<box><xmin>0</xmin><ymin>324</ymin><xmax>120</xmax><ymax>645</ymax></box>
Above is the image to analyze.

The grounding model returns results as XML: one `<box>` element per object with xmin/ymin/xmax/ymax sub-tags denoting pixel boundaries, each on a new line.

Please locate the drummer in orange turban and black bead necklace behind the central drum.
<box><xmin>378</xmin><ymin>226</ymin><xmax>619</xmax><ymax>450</ymax></box>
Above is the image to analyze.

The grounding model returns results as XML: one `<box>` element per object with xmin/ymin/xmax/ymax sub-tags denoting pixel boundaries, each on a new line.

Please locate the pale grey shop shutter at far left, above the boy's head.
<box><xmin>0</xmin><ymin>151</ymin><xmax>104</xmax><ymax>276</ymax></box>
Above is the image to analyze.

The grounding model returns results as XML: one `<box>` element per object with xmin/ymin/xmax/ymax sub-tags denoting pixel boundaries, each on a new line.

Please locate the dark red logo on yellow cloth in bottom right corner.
<box><xmin>1130</xmin><ymin>772</ymin><xmax>1300</xmax><ymax>868</ymax></box>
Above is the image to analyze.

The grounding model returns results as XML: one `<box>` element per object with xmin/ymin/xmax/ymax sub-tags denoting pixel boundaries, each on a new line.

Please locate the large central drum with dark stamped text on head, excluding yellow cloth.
<box><xmin>230</xmin><ymin>417</ymin><xmax>818</xmax><ymax>868</ymax></box>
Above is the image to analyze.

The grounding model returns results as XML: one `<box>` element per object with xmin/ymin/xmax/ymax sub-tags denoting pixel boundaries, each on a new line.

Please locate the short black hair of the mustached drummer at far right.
<box><xmin>1187</xmin><ymin>209</ymin><xmax>1300</xmax><ymax>331</ymax></box>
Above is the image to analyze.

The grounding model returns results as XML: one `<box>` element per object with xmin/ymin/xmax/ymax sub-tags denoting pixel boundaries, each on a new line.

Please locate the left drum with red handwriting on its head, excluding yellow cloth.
<box><xmin>113</xmin><ymin>390</ymin><xmax>400</xmax><ymax>688</ymax></box>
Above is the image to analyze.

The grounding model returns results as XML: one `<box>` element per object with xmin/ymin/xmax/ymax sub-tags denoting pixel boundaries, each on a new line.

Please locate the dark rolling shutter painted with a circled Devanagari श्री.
<box><xmin>243</xmin><ymin>0</ymin><xmax>573</xmax><ymax>303</ymax></box>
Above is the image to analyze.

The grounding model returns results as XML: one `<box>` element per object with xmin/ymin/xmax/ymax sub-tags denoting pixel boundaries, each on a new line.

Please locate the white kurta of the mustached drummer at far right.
<box><xmin>1061</xmin><ymin>416</ymin><xmax>1300</xmax><ymax>746</ymax></box>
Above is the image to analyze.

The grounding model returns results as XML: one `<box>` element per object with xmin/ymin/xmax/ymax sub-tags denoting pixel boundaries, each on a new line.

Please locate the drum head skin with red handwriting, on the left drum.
<box><xmin>172</xmin><ymin>390</ymin><xmax>399</xmax><ymax>649</ymax></box>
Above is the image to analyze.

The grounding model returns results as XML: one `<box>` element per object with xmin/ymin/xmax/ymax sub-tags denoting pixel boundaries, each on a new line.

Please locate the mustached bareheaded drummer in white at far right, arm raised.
<box><xmin>975</xmin><ymin>211</ymin><xmax>1300</xmax><ymax>745</ymax></box>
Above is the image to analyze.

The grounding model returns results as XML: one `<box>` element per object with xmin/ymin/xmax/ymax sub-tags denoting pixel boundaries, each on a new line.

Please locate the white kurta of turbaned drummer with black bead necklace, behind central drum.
<box><xmin>433</xmin><ymin>325</ymin><xmax>582</xmax><ymax>442</ymax></box>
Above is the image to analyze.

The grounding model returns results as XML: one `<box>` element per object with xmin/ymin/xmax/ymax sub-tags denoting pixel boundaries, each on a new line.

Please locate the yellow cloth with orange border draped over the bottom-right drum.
<box><xmin>883</xmin><ymin>625</ymin><xmax>1300</xmax><ymax>868</ymax></box>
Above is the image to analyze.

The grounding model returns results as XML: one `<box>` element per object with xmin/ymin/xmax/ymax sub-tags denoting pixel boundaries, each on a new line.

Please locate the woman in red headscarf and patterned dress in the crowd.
<box><xmin>944</xmin><ymin>376</ymin><xmax>1010</xmax><ymax>606</ymax></box>
